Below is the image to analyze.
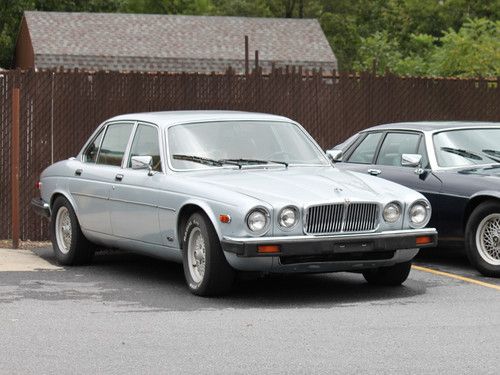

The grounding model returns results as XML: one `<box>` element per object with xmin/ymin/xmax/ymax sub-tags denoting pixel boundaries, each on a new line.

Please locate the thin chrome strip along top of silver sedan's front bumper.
<box><xmin>222</xmin><ymin>228</ymin><xmax>437</xmax><ymax>245</ymax></box>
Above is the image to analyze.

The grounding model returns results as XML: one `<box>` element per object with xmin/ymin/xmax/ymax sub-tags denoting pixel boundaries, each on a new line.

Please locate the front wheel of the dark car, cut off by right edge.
<box><xmin>465</xmin><ymin>202</ymin><xmax>500</xmax><ymax>277</ymax></box>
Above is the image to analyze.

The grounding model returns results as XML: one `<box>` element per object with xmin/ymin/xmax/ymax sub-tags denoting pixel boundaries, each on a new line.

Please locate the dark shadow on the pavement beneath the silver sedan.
<box><xmin>17</xmin><ymin>249</ymin><xmax>426</xmax><ymax>311</ymax></box>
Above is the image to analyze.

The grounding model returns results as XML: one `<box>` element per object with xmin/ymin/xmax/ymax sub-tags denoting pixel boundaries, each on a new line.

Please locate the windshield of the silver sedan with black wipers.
<box><xmin>168</xmin><ymin>121</ymin><xmax>330</xmax><ymax>169</ymax></box>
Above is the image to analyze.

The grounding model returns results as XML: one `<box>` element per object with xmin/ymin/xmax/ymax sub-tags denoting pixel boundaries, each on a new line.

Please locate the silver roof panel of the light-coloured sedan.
<box><xmin>107</xmin><ymin>111</ymin><xmax>294</xmax><ymax>128</ymax></box>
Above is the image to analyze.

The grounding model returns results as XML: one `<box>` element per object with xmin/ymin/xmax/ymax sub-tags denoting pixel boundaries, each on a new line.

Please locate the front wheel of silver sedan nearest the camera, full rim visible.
<box><xmin>182</xmin><ymin>213</ymin><xmax>235</xmax><ymax>296</ymax></box>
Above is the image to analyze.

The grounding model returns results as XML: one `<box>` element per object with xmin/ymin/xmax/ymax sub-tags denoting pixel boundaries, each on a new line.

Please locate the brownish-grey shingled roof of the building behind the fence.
<box><xmin>18</xmin><ymin>11</ymin><xmax>337</xmax><ymax>72</ymax></box>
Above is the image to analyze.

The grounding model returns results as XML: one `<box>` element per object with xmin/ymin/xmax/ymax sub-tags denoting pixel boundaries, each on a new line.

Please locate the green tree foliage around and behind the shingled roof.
<box><xmin>0</xmin><ymin>0</ymin><xmax>500</xmax><ymax>77</ymax></box>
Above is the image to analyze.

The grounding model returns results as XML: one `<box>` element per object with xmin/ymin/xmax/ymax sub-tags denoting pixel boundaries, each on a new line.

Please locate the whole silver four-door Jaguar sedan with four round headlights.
<box><xmin>33</xmin><ymin>111</ymin><xmax>437</xmax><ymax>295</ymax></box>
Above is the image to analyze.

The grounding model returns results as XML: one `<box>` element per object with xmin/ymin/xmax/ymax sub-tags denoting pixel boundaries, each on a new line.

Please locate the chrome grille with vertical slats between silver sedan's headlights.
<box><xmin>305</xmin><ymin>203</ymin><xmax>378</xmax><ymax>234</ymax></box>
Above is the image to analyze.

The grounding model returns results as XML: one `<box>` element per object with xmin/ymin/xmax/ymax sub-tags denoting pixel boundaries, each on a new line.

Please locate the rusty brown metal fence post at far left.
<box><xmin>11</xmin><ymin>87</ymin><xmax>20</xmax><ymax>249</ymax></box>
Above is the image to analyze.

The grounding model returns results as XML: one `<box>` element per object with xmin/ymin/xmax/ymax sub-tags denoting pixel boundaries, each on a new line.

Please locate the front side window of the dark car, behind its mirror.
<box><xmin>377</xmin><ymin>133</ymin><xmax>420</xmax><ymax>167</ymax></box>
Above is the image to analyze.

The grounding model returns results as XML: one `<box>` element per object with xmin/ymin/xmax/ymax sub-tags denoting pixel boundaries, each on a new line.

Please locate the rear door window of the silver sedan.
<box><xmin>97</xmin><ymin>124</ymin><xmax>133</xmax><ymax>166</ymax></box>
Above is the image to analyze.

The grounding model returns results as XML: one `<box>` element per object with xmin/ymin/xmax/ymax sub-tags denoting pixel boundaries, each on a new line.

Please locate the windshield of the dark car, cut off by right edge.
<box><xmin>434</xmin><ymin>128</ymin><xmax>500</xmax><ymax>167</ymax></box>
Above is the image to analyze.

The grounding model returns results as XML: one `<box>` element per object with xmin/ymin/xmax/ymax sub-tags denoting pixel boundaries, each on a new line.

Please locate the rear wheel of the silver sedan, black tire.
<box><xmin>50</xmin><ymin>196</ymin><xmax>95</xmax><ymax>266</ymax></box>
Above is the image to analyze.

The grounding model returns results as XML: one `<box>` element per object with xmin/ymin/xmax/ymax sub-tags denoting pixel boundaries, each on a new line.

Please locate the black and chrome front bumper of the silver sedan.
<box><xmin>221</xmin><ymin>228</ymin><xmax>437</xmax><ymax>259</ymax></box>
